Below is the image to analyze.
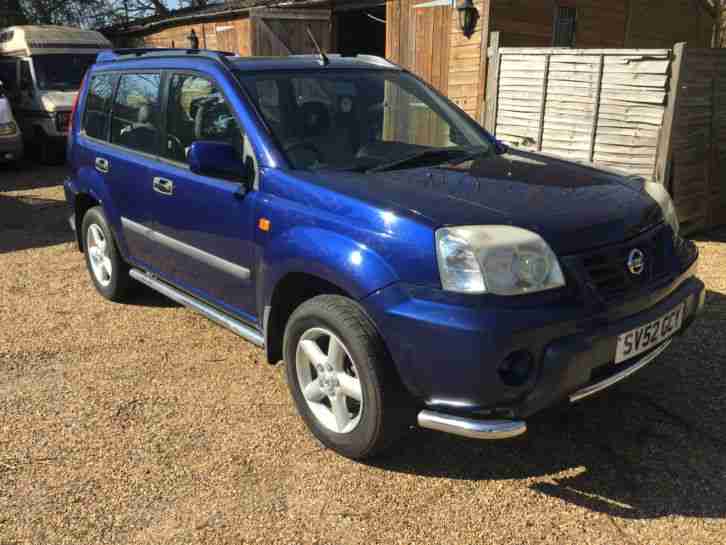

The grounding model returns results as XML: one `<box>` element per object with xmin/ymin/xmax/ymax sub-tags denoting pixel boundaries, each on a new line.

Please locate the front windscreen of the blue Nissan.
<box><xmin>238</xmin><ymin>69</ymin><xmax>491</xmax><ymax>171</ymax></box>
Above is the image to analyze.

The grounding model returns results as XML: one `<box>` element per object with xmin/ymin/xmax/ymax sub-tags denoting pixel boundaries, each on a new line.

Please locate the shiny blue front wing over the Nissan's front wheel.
<box><xmin>258</xmin><ymin>226</ymin><xmax>398</xmax><ymax>309</ymax></box>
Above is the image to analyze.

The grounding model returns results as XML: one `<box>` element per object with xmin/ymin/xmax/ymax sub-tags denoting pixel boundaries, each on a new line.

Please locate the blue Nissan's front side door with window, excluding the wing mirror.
<box><xmin>150</xmin><ymin>72</ymin><xmax>257</xmax><ymax>322</ymax></box>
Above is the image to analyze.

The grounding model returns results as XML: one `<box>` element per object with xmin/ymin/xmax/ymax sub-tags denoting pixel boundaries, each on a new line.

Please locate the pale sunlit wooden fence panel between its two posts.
<box><xmin>487</xmin><ymin>47</ymin><xmax>671</xmax><ymax>179</ymax></box>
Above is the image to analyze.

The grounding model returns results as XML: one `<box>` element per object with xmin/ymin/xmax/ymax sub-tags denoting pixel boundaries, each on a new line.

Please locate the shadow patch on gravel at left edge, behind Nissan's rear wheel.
<box><xmin>0</xmin><ymin>193</ymin><xmax>75</xmax><ymax>254</ymax></box>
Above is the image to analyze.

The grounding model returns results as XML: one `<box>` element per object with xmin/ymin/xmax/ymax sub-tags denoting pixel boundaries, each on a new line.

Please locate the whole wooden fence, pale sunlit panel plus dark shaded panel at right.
<box><xmin>485</xmin><ymin>38</ymin><xmax>726</xmax><ymax>234</ymax></box>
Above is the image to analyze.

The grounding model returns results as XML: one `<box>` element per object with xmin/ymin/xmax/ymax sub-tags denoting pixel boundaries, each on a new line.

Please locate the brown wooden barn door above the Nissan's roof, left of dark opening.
<box><xmin>250</xmin><ymin>9</ymin><xmax>332</xmax><ymax>57</ymax></box>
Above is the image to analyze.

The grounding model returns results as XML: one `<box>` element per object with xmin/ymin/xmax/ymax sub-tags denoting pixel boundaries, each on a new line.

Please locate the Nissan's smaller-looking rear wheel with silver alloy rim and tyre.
<box><xmin>81</xmin><ymin>206</ymin><xmax>133</xmax><ymax>302</ymax></box>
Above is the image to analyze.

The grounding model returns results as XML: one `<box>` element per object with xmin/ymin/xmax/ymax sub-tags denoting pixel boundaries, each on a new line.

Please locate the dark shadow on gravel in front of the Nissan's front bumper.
<box><xmin>375</xmin><ymin>291</ymin><xmax>726</xmax><ymax>519</ymax></box>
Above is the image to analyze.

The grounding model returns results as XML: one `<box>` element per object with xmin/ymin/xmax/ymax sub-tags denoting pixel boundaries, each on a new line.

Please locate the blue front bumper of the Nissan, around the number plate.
<box><xmin>364</xmin><ymin>262</ymin><xmax>705</xmax><ymax>437</ymax></box>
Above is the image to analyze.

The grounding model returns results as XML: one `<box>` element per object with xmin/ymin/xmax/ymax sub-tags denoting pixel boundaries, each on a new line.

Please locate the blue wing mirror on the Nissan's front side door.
<box><xmin>187</xmin><ymin>140</ymin><xmax>254</xmax><ymax>193</ymax></box>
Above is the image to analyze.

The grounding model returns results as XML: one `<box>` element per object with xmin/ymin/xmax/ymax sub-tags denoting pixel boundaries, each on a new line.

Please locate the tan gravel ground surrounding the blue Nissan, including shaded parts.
<box><xmin>0</xmin><ymin>165</ymin><xmax>726</xmax><ymax>545</ymax></box>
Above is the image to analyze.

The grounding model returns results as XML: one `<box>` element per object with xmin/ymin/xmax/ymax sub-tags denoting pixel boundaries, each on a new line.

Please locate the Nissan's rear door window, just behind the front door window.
<box><xmin>111</xmin><ymin>74</ymin><xmax>161</xmax><ymax>154</ymax></box>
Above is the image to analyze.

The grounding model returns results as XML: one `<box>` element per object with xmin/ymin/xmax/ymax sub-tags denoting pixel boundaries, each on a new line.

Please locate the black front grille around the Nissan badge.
<box><xmin>579</xmin><ymin>225</ymin><xmax>673</xmax><ymax>300</ymax></box>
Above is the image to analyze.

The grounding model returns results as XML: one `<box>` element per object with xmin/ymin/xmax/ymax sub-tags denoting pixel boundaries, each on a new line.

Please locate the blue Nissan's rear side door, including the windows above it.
<box><xmin>81</xmin><ymin>72</ymin><xmax>161</xmax><ymax>271</ymax></box>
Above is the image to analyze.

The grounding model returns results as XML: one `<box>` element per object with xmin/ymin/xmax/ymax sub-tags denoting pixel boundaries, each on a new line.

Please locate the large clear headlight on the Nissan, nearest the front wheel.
<box><xmin>436</xmin><ymin>225</ymin><xmax>565</xmax><ymax>295</ymax></box>
